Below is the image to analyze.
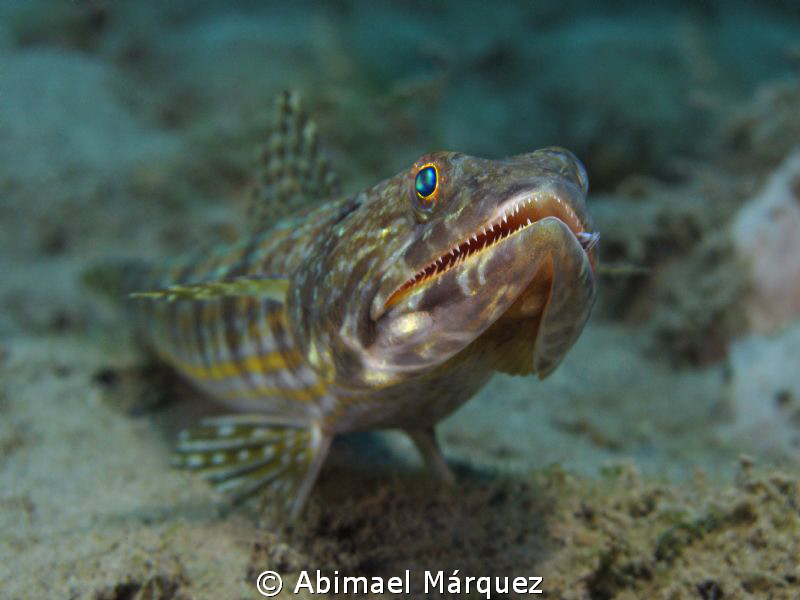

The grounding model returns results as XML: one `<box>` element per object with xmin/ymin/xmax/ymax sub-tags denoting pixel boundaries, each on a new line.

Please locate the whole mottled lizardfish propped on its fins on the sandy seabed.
<box><xmin>89</xmin><ymin>94</ymin><xmax>598</xmax><ymax>516</ymax></box>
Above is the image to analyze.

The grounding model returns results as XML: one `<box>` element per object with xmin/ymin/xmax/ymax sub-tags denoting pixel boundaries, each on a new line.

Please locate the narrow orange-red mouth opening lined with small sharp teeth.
<box><xmin>384</xmin><ymin>196</ymin><xmax>599</xmax><ymax>308</ymax></box>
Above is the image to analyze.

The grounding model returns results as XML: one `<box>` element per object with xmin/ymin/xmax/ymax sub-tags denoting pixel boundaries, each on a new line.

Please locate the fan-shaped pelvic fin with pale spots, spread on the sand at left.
<box><xmin>172</xmin><ymin>415</ymin><xmax>331</xmax><ymax>518</ymax></box>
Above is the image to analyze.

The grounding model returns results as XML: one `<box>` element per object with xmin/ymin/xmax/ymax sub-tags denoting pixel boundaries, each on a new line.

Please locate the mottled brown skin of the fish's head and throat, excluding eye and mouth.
<box><xmin>288</xmin><ymin>149</ymin><xmax>594</xmax><ymax>432</ymax></box>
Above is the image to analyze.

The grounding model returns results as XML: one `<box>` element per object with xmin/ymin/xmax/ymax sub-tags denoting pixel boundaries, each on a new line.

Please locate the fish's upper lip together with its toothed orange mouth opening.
<box><xmin>370</xmin><ymin>180</ymin><xmax>599</xmax><ymax>320</ymax></box>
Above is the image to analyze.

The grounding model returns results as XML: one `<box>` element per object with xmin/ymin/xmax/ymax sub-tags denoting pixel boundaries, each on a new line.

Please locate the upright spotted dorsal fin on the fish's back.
<box><xmin>247</xmin><ymin>92</ymin><xmax>339</xmax><ymax>232</ymax></box>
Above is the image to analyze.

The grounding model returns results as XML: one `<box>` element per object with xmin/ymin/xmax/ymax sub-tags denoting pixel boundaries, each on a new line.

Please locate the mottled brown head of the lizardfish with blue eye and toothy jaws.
<box><xmin>288</xmin><ymin>148</ymin><xmax>598</xmax><ymax>387</ymax></box>
